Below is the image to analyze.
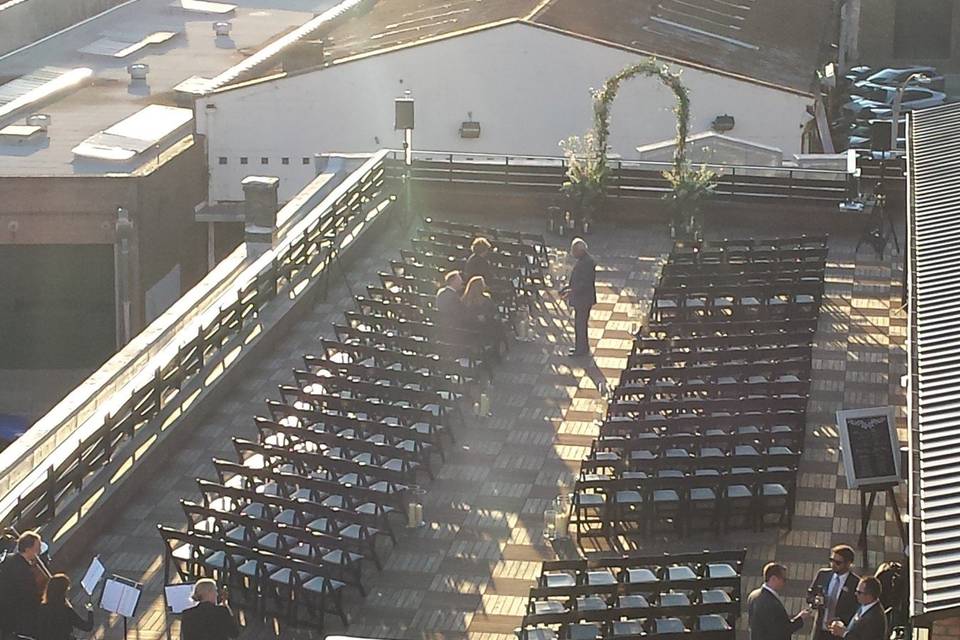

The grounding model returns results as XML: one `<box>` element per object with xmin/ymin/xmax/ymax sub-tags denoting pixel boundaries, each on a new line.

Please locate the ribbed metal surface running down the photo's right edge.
<box><xmin>908</xmin><ymin>104</ymin><xmax>960</xmax><ymax>625</ymax></box>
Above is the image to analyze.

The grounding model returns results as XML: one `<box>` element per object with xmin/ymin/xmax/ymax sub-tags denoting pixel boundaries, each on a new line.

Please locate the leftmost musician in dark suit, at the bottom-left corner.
<box><xmin>0</xmin><ymin>531</ymin><xmax>47</xmax><ymax>639</ymax></box>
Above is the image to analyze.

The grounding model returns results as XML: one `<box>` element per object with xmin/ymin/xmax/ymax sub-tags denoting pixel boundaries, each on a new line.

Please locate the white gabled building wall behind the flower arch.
<box><xmin>197</xmin><ymin>24</ymin><xmax>810</xmax><ymax>201</ymax></box>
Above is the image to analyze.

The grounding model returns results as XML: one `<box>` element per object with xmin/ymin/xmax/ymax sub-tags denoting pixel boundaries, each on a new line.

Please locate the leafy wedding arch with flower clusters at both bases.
<box><xmin>560</xmin><ymin>58</ymin><xmax>717</xmax><ymax>239</ymax></box>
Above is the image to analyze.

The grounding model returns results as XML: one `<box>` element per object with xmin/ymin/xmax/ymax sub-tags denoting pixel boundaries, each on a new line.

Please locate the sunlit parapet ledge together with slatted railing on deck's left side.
<box><xmin>0</xmin><ymin>151</ymin><xmax>395</xmax><ymax>530</ymax></box>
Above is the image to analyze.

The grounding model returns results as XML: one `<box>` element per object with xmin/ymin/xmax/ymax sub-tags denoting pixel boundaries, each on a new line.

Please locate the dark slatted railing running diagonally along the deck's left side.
<box><xmin>0</xmin><ymin>152</ymin><xmax>395</xmax><ymax>530</ymax></box>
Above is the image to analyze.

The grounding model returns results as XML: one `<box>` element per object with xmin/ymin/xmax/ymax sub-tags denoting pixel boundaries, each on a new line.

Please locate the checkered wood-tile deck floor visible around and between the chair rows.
<box><xmin>55</xmin><ymin>208</ymin><xmax>906</xmax><ymax>640</ymax></box>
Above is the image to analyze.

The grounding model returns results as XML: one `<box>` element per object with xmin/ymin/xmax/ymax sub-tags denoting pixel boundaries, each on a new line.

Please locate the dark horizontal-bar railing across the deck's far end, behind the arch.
<box><xmin>388</xmin><ymin>151</ymin><xmax>849</xmax><ymax>205</ymax></box>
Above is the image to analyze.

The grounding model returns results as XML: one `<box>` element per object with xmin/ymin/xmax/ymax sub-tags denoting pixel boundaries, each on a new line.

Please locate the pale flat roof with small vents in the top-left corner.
<box><xmin>0</xmin><ymin>0</ymin><xmax>337</xmax><ymax>177</ymax></box>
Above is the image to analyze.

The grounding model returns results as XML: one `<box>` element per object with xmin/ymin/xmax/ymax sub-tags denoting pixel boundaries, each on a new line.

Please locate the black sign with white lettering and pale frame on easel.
<box><xmin>837</xmin><ymin>407</ymin><xmax>900</xmax><ymax>489</ymax></box>
